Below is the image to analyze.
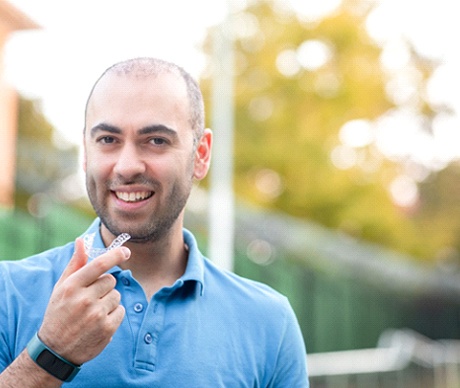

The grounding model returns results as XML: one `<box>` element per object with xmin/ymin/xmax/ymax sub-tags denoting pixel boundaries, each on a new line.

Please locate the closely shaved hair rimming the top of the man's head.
<box><xmin>85</xmin><ymin>58</ymin><xmax>204</xmax><ymax>144</ymax></box>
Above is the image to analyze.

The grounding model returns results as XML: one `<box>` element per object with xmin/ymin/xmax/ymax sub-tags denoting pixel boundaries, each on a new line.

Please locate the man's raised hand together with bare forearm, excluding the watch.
<box><xmin>0</xmin><ymin>239</ymin><xmax>130</xmax><ymax>388</ymax></box>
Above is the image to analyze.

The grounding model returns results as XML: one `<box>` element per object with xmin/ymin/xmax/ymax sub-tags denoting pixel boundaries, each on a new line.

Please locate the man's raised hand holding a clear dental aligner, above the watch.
<box><xmin>38</xmin><ymin>239</ymin><xmax>131</xmax><ymax>365</ymax></box>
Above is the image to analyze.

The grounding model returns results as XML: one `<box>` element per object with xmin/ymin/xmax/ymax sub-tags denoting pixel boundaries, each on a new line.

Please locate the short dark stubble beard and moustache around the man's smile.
<box><xmin>86</xmin><ymin>176</ymin><xmax>193</xmax><ymax>242</ymax></box>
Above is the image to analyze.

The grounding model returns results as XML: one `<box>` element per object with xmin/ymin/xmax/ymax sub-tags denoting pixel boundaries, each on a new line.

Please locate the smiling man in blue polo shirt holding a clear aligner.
<box><xmin>0</xmin><ymin>58</ymin><xmax>308</xmax><ymax>388</ymax></box>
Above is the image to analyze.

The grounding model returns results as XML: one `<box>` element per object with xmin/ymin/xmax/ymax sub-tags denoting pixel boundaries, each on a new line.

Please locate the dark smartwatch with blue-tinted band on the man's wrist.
<box><xmin>27</xmin><ymin>333</ymin><xmax>81</xmax><ymax>382</ymax></box>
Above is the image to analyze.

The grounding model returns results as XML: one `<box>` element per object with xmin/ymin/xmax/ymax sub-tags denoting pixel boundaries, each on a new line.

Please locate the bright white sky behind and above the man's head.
<box><xmin>5</xmin><ymin>0</ymin><xmax>232</xmax><ymax>144</ymax></box>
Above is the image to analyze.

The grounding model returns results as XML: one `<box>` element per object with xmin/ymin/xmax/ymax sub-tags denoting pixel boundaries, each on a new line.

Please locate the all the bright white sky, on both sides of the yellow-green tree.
<box><xmin>2</xmin><ymin>0</ymin><xmax>460</xmax><ymax>182</ymax></box>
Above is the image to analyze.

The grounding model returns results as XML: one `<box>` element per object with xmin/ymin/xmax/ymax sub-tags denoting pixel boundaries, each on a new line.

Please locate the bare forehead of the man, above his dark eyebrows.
<box><xmin>86</xmin><ymin>72</ymin><xmax>190</xmax><ymax>129</ymax></box>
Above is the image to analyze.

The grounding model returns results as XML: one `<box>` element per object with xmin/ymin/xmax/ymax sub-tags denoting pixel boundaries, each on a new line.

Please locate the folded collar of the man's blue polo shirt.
<box><xmin>83</xmin><ymin>218</ymin><xmax>204</xmax><ymax>296</ymax></box>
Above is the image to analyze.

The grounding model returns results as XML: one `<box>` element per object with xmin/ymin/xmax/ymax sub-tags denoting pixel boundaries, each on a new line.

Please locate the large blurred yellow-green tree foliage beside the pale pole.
<box><xmin>202</xmin><ymin>0</ymin><xmax>439</xmax><ymax>258</ymax></box>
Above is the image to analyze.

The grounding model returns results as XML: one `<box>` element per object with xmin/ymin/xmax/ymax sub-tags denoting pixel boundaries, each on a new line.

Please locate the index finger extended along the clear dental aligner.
<box><xmin>72</xmin><ymin>247</ymin><xmax>131</xmax><ymax>286</ymax></box>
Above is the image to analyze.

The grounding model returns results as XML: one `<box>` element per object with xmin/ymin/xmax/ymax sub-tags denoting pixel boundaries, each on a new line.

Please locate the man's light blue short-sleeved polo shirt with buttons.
<box><xmin>0</xmin><ymin>219</ymin><xmax>308</xmax><ymax>388</ymax></box>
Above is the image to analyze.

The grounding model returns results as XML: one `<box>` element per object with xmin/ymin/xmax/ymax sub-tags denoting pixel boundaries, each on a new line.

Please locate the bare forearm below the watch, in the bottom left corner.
<box><xmin>0</xmin><ymin>350</ymin><xmax>62</xmax><ymax>388</ymax></box>
